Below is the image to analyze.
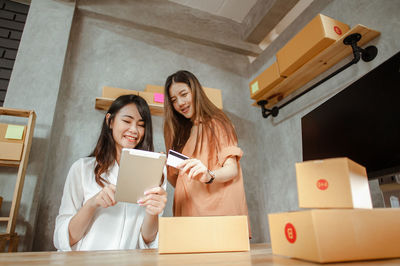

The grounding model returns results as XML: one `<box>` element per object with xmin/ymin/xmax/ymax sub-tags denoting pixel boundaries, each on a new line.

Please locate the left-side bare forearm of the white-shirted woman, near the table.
<box><xmin>68</xmin><ymin>200</ymin><xmax>96</xmax><ymax>247</ymax></box>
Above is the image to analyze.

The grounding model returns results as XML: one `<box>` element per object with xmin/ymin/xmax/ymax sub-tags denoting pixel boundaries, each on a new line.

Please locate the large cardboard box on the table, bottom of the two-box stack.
<box><xmin>268</xmin><ymin>209</ymin><xmax>400</xmax><ymax>263</ymax></box>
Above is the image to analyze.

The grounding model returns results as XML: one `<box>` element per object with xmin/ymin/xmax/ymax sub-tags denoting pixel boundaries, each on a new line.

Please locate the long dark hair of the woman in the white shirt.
<box><xmin>90</xmin><ymin>94</ymin><xmax>154</xmax><ymax>187</ymax></box>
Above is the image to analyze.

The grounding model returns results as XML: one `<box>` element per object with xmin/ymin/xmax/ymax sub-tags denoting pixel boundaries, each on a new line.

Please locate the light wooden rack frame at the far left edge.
<box><xmin>0</xmin><ymin>107</ymin><xmax>36</xmax><ymax>252</ymax></box>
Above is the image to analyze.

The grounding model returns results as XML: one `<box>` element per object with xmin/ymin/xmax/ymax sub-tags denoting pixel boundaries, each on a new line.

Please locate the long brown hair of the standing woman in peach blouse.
<box><xmin>164</xmin><ymin>70</ymin><xmax>237</xmax><ymax>155</ymax></box>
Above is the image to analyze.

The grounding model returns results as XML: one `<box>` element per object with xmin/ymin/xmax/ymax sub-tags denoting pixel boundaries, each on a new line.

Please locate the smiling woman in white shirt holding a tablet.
<box><xmin>54</xmin><ymin>95</ymin><xmax>167</xmax><ymax>251</ymax></box>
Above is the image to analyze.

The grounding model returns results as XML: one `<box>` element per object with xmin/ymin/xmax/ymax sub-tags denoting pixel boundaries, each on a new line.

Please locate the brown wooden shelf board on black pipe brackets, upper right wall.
<box><xmin>252</xmin><ymin>24</ymin><xmax>380</xmax><ymax>108</ymax></box>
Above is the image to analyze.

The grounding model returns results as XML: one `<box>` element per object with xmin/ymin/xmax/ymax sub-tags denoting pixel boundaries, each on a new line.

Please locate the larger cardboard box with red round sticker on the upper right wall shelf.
<box><xmin>276</xmin><ymin>14</ymin><xmax>350</xmax><ymax>77</ymax></box>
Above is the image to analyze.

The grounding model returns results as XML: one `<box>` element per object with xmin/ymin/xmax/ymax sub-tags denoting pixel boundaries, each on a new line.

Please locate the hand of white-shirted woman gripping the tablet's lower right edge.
<box><xmin>138</xmin><ymin>187</ymin><xmax>167</xmax><ymax>215</ymax></box>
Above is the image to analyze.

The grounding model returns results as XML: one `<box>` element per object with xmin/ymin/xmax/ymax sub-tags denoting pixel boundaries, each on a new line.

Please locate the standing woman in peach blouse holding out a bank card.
<box><xmin>164</xmin><ymin>70</ymin><xmax>248</xmax><ymax>229</ymax></box>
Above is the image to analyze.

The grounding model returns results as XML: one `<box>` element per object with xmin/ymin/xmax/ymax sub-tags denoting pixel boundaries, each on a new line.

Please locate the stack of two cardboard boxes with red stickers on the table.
<box><xmin>268</xmin><ymin>158</ymin><xmax>400</xmax><ymax>262</ymax></box>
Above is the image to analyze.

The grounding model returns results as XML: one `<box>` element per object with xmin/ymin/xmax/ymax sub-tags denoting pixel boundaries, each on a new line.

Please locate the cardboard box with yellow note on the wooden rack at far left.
<box><xmin>0</xmin><ymin>124</ymin><xmax>26</xmax><ymax>161</ymax></box>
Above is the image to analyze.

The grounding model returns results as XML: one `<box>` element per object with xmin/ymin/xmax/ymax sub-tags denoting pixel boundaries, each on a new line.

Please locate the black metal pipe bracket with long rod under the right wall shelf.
<box><xmin>257</xmin><ymin>33</ymin><xmax>378</xmax><ymax>118</ymax></box>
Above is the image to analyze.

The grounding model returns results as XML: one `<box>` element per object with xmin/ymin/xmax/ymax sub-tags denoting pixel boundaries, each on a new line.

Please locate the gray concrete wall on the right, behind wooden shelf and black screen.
<box><xmin>250</xmin><ymin>0</ymin><xmax>400</xmax><ymax>241</ymax></box>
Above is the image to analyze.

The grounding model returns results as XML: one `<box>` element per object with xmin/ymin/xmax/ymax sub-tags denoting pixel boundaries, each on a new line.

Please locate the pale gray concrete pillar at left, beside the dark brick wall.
<box><xmin>0</xmin><ymin>0</ymin><xmax>75</xmax><ymax>251</ymax></box>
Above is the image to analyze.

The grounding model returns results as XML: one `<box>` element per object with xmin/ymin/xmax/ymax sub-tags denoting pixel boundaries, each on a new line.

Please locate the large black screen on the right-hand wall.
<box><xmin>301</xmin><ymin>53</ymin><xmax>400</xmax><ymax>178</ymax></box>
